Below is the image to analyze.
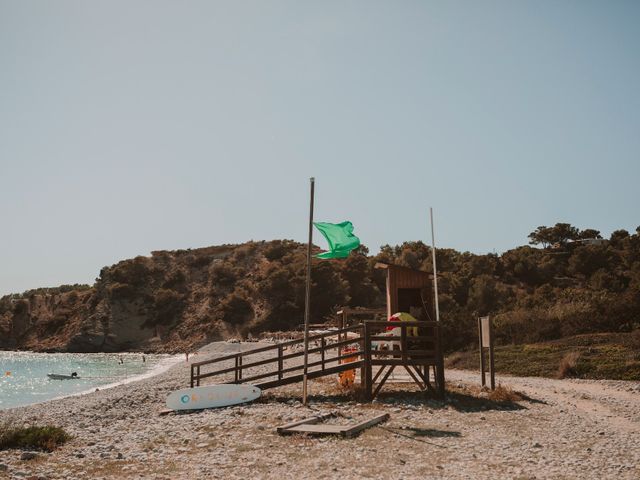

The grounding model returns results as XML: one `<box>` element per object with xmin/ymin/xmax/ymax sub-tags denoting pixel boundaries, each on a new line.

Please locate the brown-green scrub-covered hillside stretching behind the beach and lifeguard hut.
<box><xmin>0</xmin><ymin>223</ymin><xmax>640</xmax><ymax>366</ymax></box>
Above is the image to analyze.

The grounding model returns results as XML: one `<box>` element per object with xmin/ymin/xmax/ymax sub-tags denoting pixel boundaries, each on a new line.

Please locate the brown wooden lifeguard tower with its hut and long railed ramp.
<box><xmin>191</xmin><ymin>263</ymin><xmax>444</xmax><ymax>400</ymax></box>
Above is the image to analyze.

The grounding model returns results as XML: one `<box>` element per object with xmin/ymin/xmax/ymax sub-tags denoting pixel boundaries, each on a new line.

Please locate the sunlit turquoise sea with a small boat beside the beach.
<box><xmin>0</xmin><ymin>351</ymin><xmax>179</xmax><ymax>410</ymax></box>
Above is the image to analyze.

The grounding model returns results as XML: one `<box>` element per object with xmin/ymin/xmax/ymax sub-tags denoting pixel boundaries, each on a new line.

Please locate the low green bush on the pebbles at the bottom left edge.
<box><xmin>0</xmin><ymin>421</ymin><xmax>71</xmax><ymax>452</ymax></box>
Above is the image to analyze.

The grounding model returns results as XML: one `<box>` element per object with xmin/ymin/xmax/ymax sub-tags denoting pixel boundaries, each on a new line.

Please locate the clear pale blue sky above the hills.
<box><xmin>0</xmin><ymin>0</ymin><xmax>640</xmax><ymax>295</ymax></box>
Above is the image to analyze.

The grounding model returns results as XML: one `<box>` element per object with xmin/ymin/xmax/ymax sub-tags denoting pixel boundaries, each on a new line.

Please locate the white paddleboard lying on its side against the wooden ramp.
<box><xmin>167</xmin><ymin>383</ymin><xmax>262</xmax><ymax>410</ymax></box>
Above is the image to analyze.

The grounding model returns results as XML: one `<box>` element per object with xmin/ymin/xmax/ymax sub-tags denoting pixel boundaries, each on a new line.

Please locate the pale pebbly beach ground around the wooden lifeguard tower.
<box><xmin>0</xmin><ymin>343</ymin><xmax>640</xmax><ymax>479</ymax></box>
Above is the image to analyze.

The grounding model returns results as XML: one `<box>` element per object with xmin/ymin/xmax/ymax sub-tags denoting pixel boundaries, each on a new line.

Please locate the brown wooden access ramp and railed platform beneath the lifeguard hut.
<box><xmin>191</xmin><ymin>321</ymin><xmax>444</xmax><ymax>400</ymax></box>
